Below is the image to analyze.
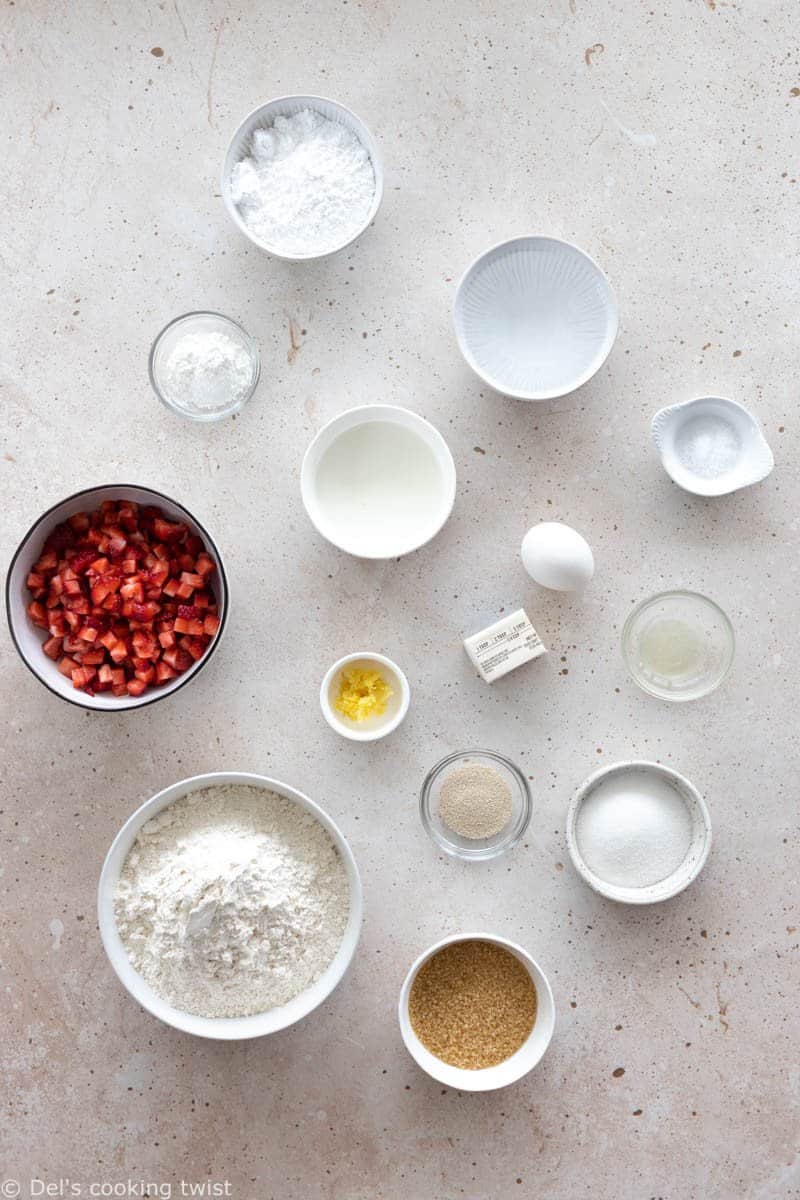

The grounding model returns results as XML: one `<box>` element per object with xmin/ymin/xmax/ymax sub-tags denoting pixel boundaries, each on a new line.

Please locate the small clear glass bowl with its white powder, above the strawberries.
<box><xmin>149</xmin><ymin>312</ymin><xmax>261</xmax><ymax>421</ymax></box>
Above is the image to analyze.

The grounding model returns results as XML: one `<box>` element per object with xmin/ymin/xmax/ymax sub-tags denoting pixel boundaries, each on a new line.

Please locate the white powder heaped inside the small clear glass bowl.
<box><xmin>158</xmin><ymin>329</ymin><xmax>253</xmax><ymax>413</ymax></box>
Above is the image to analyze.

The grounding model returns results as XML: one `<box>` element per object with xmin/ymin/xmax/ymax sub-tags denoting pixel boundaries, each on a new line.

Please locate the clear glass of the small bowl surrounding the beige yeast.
<box><xmin>420</xmin><ymin>750</ymin><xmax>533</xmax><ymax>862</ymax></box>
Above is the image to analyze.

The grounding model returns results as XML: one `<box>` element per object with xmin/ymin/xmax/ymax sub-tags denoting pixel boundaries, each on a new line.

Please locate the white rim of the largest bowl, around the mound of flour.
<box><xmin>97</xmin><ymin>770</ymin><xmax>363</xmax><ymax>1040</ymax></box>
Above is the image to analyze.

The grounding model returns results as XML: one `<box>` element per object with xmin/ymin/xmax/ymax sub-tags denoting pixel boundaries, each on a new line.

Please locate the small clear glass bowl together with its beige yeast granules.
<box><xmin>420</xmin><ymin>750</ymin><xmax>533</xmax><ymax>862</ymax></box>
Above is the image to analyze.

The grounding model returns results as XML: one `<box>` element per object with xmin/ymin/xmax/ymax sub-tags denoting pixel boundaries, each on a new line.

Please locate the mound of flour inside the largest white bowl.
<box><xmin>114</xmin><ymin>786</ymin><xmax>350</xmax><ymax>1016</ymax></box>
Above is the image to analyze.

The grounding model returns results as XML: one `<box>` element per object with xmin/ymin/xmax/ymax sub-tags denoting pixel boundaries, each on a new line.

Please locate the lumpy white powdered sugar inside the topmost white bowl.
<box><xmin>230</xmin><ymin>108</ymin><xmax>375</xmax><ymax>256</ymax></box>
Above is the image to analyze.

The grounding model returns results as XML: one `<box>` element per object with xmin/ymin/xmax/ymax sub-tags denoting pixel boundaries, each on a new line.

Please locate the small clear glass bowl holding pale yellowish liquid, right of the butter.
<box><xmin>622</xmin><ymin>592</ymin><xmax>735</xmax><ymax>702</ymax></box>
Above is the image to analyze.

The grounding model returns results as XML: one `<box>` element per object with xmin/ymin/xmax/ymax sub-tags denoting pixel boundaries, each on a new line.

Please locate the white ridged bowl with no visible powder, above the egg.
<box><xmin>453</xmin><ymin>236</ymin><xmax>619</xmax><ymax>400</ymax></box>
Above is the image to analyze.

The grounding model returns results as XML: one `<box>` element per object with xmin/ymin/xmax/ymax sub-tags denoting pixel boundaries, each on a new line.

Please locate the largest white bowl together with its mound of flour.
<box><xmin>97</xmin><ymin>772</ymin><xmax>362</xmax><ymax>1039</ymax></box>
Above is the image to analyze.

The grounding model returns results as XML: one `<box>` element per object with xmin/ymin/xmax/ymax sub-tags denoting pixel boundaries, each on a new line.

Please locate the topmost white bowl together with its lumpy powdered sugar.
<box><xmin>222</xmin><ymin>96</ymin><xmax>384</xmax><ymax>262</ymax></box>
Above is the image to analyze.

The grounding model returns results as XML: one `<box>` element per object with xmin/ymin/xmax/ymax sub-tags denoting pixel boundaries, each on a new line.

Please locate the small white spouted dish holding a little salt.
<box><xmin>651</xmin><ymin>396</ymin><xmax>775</xmax><ymax>496</ymax></box>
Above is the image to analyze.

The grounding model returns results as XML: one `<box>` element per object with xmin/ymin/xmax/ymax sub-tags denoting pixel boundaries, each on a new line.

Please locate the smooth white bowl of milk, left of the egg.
<box><xmin>300</xmin><ymin>404</ymin><xmax>456</xmax><ymax>558</ymax></box>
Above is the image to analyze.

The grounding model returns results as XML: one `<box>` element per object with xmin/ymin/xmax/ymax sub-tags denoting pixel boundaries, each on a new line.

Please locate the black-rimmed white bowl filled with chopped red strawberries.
<box><xmin>6</xmin><ymin>485</ymin><xmax>228</xmax><ymax>712</ymax></box>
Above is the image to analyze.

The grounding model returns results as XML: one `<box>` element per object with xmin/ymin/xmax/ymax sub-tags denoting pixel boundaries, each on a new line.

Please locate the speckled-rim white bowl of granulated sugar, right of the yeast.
<box><xmin>566</xmin><ymin>762</ymin><xmax>711</xmax><ymax>904</ymax></box>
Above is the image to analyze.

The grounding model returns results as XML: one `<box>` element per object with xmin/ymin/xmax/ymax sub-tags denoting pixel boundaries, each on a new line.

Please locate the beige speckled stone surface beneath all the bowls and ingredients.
<box><xmin>0</xmin><ymin>0</ymin><xmax>800</xmax><ymax>1200</ymax></box>
